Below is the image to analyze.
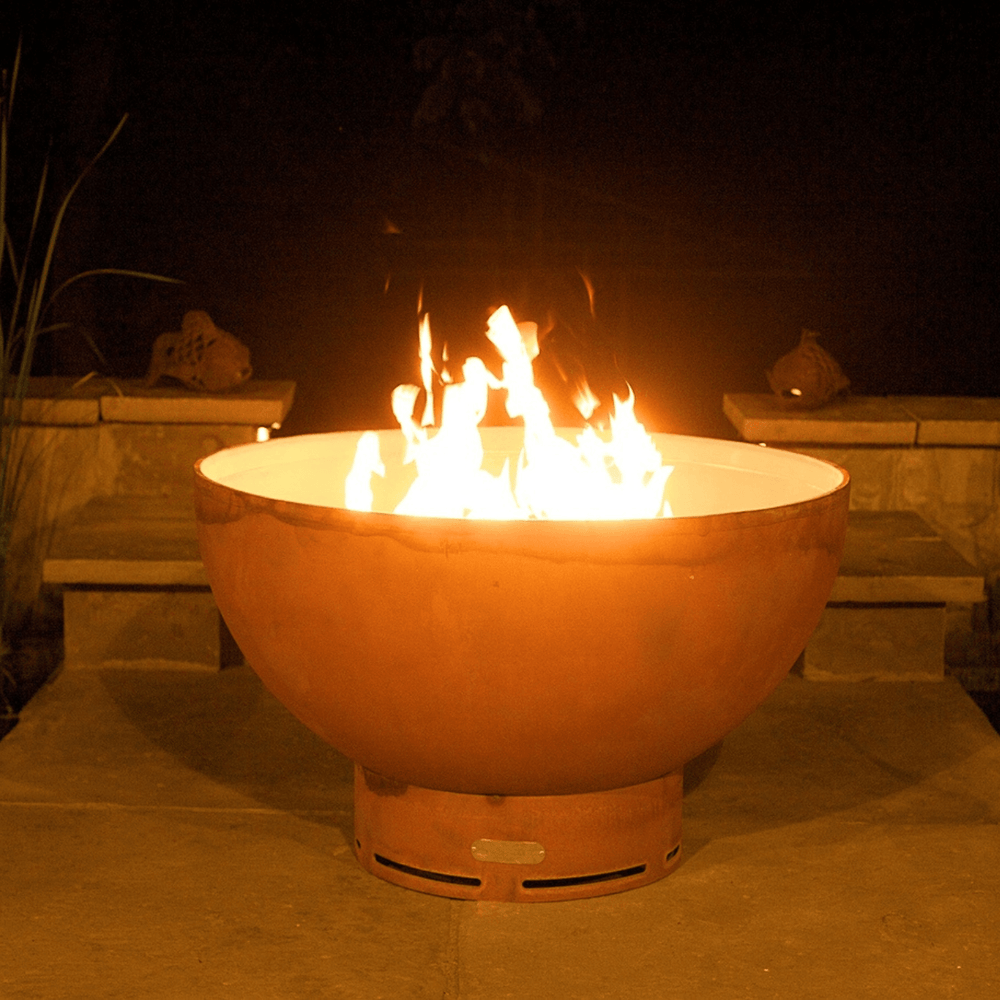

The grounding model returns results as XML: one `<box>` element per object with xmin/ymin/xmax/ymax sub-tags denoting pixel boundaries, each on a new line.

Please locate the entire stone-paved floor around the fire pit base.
<box><xmin>0</xmin><ymin>668</ymin><xmax>1000</xmax><ymax>1000</ymax></box>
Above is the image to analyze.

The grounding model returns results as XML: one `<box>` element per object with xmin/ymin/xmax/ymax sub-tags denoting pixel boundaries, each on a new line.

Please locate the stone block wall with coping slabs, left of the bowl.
<box><xmin>5</xmin><ymin>378</ymin><xmax>295</xmax><ymax>615</ymax></box>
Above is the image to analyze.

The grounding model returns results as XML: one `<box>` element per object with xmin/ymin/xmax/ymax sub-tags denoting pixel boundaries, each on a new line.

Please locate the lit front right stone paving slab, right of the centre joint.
<box><xmin>459</xmin><ymin>821</ymin><xmax>997</xmax><ymax>1000</ymax></box>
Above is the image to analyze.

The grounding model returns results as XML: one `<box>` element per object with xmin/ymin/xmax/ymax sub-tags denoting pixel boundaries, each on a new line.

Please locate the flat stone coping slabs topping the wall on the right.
<box><xmin>722</xmin><ymin>393</ymin><xmax>1000</xmax><ymax>448</ymax></box>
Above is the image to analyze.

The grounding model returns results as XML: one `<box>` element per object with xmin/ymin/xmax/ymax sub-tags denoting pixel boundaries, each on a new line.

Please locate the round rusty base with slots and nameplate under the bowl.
<box><xmin>354</xmin><ymin>765</ymin><xmax>683</xmax><ymax>903</ymax></box>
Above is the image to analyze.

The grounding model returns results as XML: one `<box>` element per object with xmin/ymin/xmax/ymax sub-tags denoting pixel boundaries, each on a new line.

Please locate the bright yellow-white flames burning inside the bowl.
<box><xmin>345</xmin><ymin>306</ymin><xmax>673</xmax><ymax>520</ymax></box>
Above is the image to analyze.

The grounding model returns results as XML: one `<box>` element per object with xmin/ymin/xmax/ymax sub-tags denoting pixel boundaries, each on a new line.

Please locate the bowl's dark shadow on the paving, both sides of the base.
<box><xmin>90</xmin><ymin>667</ymin><xmax>991</xmax><ymax>855</ymax></box>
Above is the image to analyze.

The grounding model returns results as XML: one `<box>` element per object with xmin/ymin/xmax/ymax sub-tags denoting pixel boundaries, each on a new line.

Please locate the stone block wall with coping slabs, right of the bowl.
<box><xmin>723</xmin><ymin>394</ymin><xmax>1000</xmax><ymax>690</ymax></box>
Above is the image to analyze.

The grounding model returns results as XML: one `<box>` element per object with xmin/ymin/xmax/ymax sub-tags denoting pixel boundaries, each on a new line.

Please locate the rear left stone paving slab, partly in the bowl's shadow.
<box><xmin>0</xmin><ymin>668</ymin><xmax>354</xmax><ymax>816</ymax></box>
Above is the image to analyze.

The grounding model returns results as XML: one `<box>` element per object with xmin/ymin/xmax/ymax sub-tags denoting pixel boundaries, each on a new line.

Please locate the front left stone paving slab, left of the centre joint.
<box><xmin>0</xmin><ymin>808</ymin><xmax>455</xmax><ymax>1000</ymax></box>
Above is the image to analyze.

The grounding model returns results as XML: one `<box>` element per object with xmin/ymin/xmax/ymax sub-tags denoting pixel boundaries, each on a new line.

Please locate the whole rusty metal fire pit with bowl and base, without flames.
<box><xmin>195</xmin><ymin>428</ymin><xmax>848</xmax><ymax>901</ymax></box>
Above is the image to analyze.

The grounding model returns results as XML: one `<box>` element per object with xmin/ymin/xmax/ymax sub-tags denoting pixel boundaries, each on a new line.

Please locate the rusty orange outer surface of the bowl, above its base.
<box><xmin>195</xmin><ymin>430</ymin><xmax>848</xmax><ymax>795</ymax></box>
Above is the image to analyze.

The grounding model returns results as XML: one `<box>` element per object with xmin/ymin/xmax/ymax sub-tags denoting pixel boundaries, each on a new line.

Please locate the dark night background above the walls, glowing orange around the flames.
<box><xmin>0</xmin><ymin>0</ymin><xmax>1000</xmax><ymax>434</ymax></box>
